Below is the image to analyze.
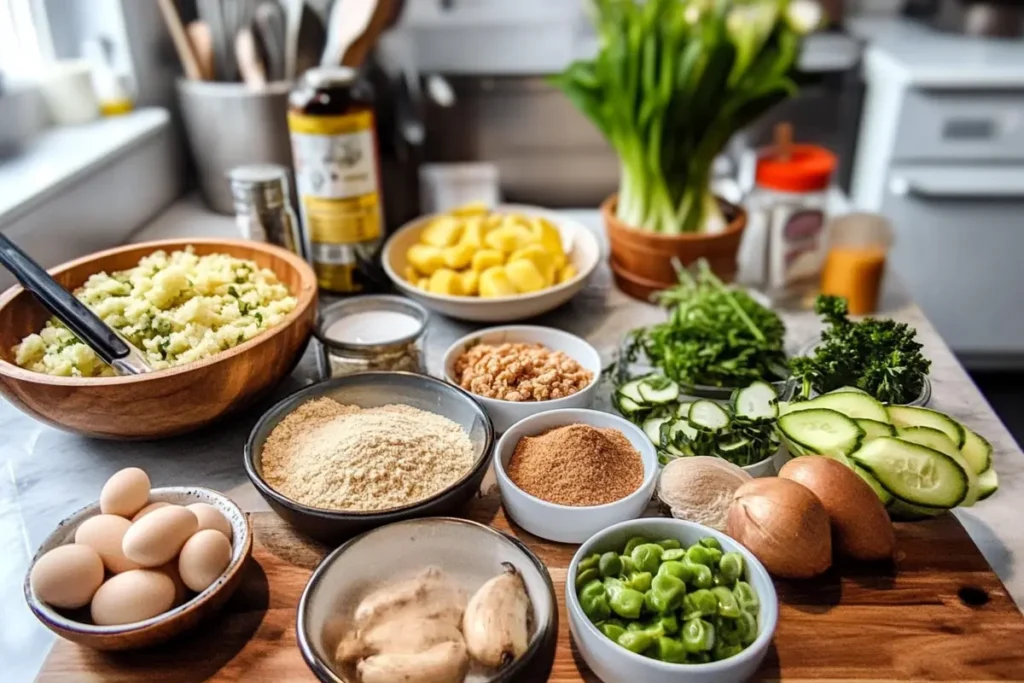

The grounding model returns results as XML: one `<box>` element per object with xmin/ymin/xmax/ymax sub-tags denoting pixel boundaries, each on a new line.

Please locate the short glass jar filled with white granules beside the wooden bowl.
<box><xmin>315</xmin><ymin>294</ymin><xmax>430</xmax><ymax>377</ymax></box>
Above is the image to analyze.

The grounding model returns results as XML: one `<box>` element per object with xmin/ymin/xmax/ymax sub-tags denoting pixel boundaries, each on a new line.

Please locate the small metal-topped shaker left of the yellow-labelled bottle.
<box><xmin>227</xmin><ymin>164</ymin><xmax>309</xmax><ymax>260</ymax></box>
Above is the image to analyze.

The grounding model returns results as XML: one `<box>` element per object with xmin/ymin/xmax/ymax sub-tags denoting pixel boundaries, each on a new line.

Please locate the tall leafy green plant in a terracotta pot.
<box><xmin>553</xmin><ymin>0</ymin><xmax>821</xmax><ymax>298</ymax></box>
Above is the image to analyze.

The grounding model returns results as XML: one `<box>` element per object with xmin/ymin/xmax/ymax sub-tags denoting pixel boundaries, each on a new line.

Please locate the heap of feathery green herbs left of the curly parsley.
<box><xmin>622</xmin><ymin>260</ymin><xmax>786</xmax><ymax>387</ymax></box>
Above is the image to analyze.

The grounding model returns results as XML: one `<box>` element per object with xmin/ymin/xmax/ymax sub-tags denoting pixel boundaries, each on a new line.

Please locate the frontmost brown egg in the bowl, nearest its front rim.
<box><xmin>91</xmin><ymin>569</ymin><xmax>174</xmax><ymax>626</ymax></box>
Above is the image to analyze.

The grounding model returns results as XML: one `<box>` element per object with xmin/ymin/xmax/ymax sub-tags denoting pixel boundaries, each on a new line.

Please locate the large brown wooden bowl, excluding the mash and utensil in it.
<box><xmin>0</xmin><ymin>240</ymin><xmax>316</xmax><ymax>438</ymax></box>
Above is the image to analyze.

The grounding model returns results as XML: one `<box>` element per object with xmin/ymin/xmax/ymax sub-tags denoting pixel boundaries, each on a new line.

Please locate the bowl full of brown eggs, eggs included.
<box><xmin>25</xmin><ymin>467</ymin><xmax>252</xmax><ymax>650</ymax></box>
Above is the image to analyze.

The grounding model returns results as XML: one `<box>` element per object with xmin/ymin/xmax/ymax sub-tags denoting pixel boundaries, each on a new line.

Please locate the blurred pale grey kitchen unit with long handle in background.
<box><xmin>852</xmin><ymin>15</ymin><xmax>1024</xmax><ymax>368</ymax></box>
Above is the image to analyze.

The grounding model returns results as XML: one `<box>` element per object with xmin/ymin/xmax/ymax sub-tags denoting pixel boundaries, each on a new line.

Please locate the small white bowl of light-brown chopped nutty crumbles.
<box><xmin>443</xmin><ymin>325</ymin><xmax>601</xmax><ymax>433</ymax></box>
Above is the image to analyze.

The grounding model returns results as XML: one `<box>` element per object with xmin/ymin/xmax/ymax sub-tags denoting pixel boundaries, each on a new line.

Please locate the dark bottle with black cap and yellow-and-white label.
<box><xmin>288</xmin><ymin>67</ymin><xmax>383</xmax><ymax>294</ymax></box>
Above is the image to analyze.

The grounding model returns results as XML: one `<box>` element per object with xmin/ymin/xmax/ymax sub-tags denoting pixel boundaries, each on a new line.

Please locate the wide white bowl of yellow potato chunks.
<box><xmin>383</xmin><ymin>204</ymin><xmax>600</xmax><ymax>323</ymax></box>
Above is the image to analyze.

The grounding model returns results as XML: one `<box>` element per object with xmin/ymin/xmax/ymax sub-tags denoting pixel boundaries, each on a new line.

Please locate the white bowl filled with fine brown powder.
<box><xmin>495</xmin><ymin>410</ymin><xmax>657</xmax><ymax>543</ymax></box>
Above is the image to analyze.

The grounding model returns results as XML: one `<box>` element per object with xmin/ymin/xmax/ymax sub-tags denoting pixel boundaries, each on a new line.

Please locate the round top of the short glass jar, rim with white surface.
<box><xmin>314</xmin><ymin>294</ymin><xmax>430</xmax><ymax>353</ymax></box>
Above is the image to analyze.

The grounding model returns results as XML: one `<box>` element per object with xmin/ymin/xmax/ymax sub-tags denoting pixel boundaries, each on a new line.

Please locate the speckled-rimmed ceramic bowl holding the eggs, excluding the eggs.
<box><xmin>25</xmin><ymin>486</ymin><xmax>253</xmax><ymax>650</ymax></box>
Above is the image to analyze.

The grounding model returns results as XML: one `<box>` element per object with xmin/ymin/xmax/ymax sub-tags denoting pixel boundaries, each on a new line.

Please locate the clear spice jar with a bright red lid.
<box><xmin>746</xmin><ymin>129</ymin><xmax>836</xmax><ymax>307</ymax></box>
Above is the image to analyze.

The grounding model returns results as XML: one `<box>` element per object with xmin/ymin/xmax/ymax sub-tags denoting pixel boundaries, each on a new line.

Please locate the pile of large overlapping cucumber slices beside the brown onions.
<box><xmin>778</xmin><ymin>387</ymin><xmax>998</xmax><ymax>519</ymax></box>
